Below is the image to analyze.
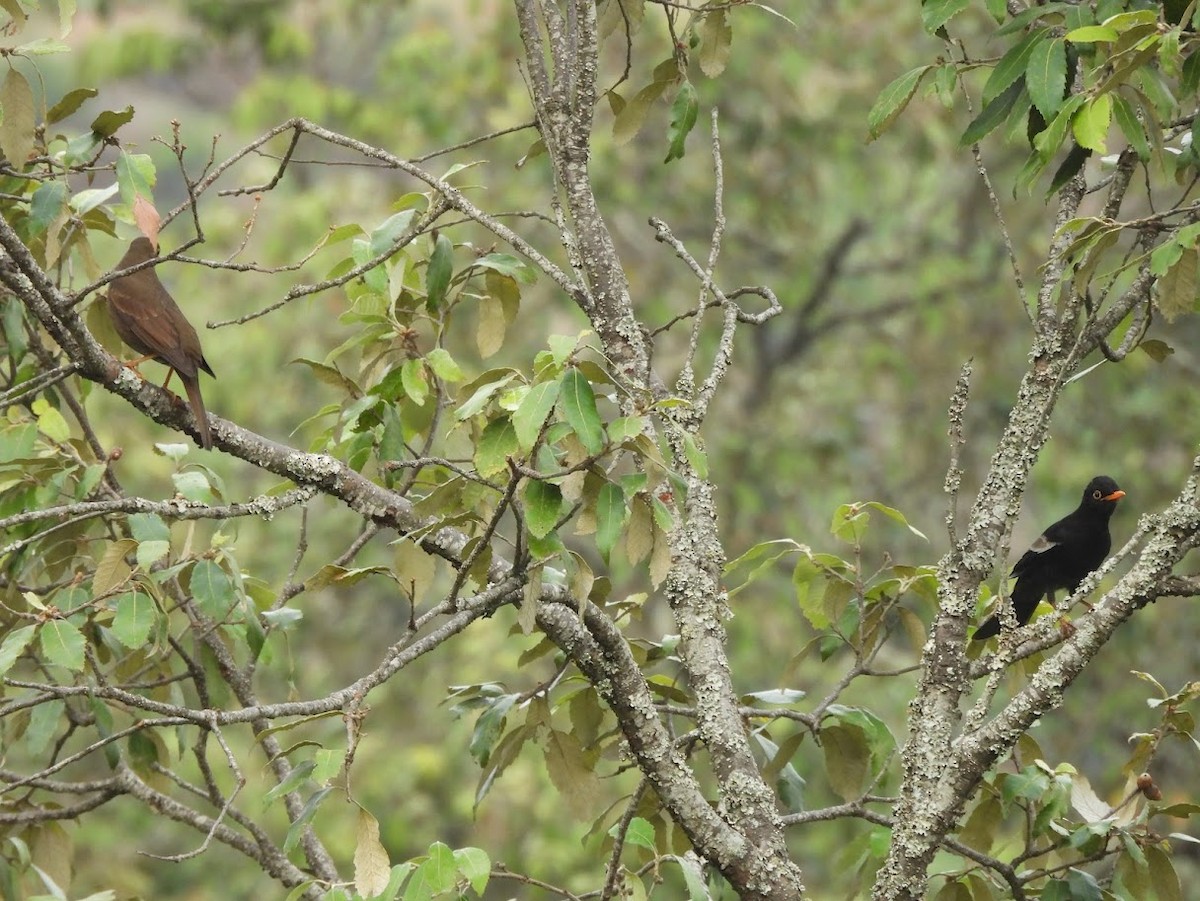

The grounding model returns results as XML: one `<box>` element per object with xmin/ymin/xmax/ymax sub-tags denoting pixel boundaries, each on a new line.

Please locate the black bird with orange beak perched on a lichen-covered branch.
<box><xmin>971</xmin><ymin>475</ymin><xmax>1124</xmax><ymax>641</ymax></box>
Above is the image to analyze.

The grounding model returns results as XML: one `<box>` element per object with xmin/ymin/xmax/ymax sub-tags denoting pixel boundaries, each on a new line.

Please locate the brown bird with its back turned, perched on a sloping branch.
<box><xmin>108</xmin><ymin>238</ymin><xmax>216</xmax><ymax>450</ymax></box>
